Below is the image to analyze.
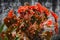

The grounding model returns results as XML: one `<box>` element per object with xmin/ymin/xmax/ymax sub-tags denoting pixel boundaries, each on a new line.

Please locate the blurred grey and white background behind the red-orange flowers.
<box><xmin>0</xmin><ymin>0</ymin><xmax>60</xmax><ymax>40</ymax></box>
